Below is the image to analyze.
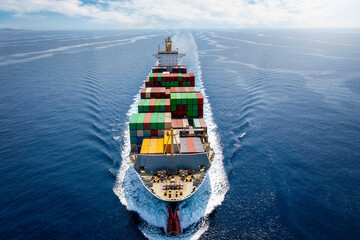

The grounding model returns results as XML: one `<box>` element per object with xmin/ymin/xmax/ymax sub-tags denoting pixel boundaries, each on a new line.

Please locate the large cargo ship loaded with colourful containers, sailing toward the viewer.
<box><xmin>129</xmin><ymin>37</ymin><xmax>215</xmax><ymax>235</ymax></box>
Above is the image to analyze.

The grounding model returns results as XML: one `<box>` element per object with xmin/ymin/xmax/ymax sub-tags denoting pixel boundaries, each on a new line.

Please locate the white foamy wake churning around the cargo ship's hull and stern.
<box><xmin>113</xmin><ymin>33</ymin><xmax>229</xmax><ymax>239</ymax></box>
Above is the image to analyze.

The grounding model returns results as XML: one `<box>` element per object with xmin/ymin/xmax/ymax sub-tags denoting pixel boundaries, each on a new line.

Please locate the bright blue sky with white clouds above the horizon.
<box><xmin>0</xmin><ymin>0</ymin><xmax>360</xmax><ymax>30</ymax></box>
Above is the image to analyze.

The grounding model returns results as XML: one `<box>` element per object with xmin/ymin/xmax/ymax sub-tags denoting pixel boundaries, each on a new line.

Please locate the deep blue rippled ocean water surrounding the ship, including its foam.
<box><xmin>0</xmin><ymin>29</ymin><xmax>360</xmax><ymax>239</ymax></box>
